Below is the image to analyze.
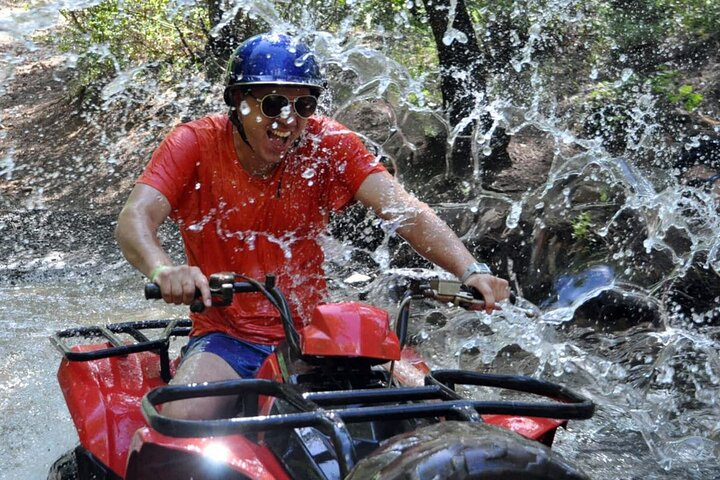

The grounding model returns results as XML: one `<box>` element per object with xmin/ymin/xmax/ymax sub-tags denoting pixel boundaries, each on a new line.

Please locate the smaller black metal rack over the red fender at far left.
<box><xmin>50</xmin><ymin>319</ymin><xmax>191</xmax><ymax>382</ymax></box>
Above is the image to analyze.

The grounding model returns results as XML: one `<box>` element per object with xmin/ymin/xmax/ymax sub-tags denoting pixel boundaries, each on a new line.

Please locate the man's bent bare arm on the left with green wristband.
<box><xmin>115</xmin><ymin>183</ymin><xmax>212</xmax><ymax>307</ymax></box>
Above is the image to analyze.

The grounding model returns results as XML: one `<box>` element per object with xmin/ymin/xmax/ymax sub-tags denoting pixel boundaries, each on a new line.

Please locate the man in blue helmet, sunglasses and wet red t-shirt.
<box><xmin>116</xmin><ymin>34</ymin><xmax>509</xmax><ymax>418</ymax></box>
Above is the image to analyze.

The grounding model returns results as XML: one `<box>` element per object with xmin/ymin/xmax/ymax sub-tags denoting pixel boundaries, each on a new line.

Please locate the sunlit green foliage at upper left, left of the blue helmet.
<box><xmin>56</xmin><ymin>0</ymin><xmax>206</xmax><ymax>99</ymax></box>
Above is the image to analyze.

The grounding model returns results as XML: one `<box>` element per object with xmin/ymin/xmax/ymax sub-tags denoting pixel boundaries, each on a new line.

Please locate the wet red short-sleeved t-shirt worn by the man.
<box><xmin>138</xmin><ymin>115</ymin><xmax>384</xmax><ymax>344</ymax></box>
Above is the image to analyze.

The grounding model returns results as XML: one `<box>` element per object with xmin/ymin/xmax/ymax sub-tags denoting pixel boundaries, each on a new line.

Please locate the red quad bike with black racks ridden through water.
<box><xmin>49</xmin><ymin>273</ymin><xmax>594</xmax><ymax>480</ymax></box>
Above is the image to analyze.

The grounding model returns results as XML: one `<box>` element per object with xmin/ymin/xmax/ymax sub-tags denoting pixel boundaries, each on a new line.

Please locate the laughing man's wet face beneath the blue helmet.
<box><xmin>235</xmin><ymin>85</ymin><xmax>310</xmax><ymax>166</ymax></box>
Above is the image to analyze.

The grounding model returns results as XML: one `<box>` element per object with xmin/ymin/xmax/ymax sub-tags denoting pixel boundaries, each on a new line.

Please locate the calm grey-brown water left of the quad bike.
<box><xmin>0</xmin><ymin>277</ymin><xmax>184</xmax><ymax>480</ymax></box>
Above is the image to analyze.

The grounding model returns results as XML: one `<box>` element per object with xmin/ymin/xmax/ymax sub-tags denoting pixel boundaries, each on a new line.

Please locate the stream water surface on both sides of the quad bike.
<box><xmin>0</xmin><ymin>274</ymin><xmax>720</xmax><ymax>479</ymax></box>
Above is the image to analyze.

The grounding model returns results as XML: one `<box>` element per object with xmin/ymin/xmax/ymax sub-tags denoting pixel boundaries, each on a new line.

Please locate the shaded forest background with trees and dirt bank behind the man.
<box><xmin>0</xmin><ymin>0</ymin><xmax>720</xmax><ymax>296</ymax></box>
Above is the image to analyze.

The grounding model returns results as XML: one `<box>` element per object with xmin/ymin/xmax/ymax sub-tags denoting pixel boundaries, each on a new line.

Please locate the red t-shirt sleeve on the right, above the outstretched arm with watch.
<box><xmin>326</xmin><ymin>122</ymin><xmax>385</xmax><ymax>211</ymax></box>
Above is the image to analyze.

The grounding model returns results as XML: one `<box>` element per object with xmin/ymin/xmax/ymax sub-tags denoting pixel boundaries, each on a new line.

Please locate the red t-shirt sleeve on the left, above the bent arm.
<box><xmin>137</xmin><ymin>125</ymin><xmax>200</xmax><ymax>210</ymax></box>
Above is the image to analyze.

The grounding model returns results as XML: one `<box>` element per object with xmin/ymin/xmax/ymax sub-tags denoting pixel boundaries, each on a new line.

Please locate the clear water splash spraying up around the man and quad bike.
<box><xmin>0</xmin><ymin>0</ymin><xmax>720</xmax><ymax>478</ymax></box>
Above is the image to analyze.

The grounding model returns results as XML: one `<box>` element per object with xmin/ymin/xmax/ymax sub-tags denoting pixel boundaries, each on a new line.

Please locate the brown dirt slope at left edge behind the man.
<box><xmin>0</xmin><ymin>18</ymin><xmax>172</xmax><ymax>284</ymax></box>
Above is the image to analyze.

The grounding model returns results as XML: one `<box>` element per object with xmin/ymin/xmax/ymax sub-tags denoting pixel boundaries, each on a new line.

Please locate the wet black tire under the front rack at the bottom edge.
<box><xmin>346</xmin><ymin>422</ymin><xmax>589</xmax><ymax>480</ymax></box>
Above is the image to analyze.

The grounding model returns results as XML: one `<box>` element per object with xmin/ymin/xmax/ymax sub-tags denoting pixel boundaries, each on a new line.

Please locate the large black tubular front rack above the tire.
<box><xmin>142</xmin><ymin>370</ymin><xmax>595</xmax><ymax>477</ymax></box>
